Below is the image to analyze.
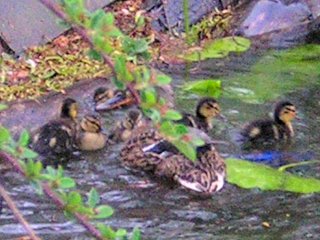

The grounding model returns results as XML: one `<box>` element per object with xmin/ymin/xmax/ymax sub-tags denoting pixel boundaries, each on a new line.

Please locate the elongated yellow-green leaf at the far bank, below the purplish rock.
<box><xmin>183</xmin><ymin>37</ymin><xmax>250</xmax><ymax>62</ymax></box>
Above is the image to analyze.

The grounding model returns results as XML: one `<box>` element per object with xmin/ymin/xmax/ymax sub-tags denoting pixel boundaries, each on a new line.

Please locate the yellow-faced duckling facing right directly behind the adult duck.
<box><xmin>177</xmin><ymin>97</ymin><xmax>224</xmax><ymax>132</ymax></box>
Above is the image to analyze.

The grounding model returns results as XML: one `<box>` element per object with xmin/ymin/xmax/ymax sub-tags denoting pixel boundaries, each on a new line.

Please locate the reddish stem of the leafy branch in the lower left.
<box><xmin>0</xmin><ymin>151</ymin><xmax>104</xmax><ymax>240</ymax></box>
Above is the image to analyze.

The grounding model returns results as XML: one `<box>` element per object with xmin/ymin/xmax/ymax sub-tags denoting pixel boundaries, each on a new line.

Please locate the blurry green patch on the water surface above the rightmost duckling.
<box><xmin>223</xmin><ymin>45</ymin><xmax>320</xmax><ymax>103</ymax></box>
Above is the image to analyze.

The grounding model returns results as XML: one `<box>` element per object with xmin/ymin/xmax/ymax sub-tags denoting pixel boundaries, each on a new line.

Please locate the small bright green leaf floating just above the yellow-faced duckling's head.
<box><xmin>183</xmin><ymin>79</ymin><xmax>221</xmax><ymax>97</ymax></box>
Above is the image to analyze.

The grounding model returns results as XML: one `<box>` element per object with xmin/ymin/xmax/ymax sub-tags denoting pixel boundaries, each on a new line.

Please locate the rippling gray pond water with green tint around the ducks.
<box><xmin>0</xmin><ymin>44</ymin><xmax>320</xmax><ymax>240</ymax></box>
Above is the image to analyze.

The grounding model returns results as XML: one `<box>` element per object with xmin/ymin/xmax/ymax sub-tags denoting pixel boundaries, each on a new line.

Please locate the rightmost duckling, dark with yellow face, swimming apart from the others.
<box><xmin>241</xmin><ymin>101</ymin><xmax>297</xmax><ymax>142</ymax></box>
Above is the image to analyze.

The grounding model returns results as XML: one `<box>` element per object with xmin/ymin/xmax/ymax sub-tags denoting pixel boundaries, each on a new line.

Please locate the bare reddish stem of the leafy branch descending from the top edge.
<box><xmin>38</xmin><ymin>0</ymin><xmax>117</xmax><ymax>77</ymax></box>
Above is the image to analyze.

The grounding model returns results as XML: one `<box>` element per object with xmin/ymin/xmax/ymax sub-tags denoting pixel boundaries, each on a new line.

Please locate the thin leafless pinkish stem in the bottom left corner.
<box><xmin>0</xmin><ymin>183</ymin><xmax>41</xmax><ymax>240</ymax></box>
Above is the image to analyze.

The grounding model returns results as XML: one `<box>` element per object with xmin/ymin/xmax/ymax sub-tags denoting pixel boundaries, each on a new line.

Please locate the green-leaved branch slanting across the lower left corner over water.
<box><xmin>0</xmin><ymin>126</ymin><xmax>140</xmax><ymax>239</ymax></box>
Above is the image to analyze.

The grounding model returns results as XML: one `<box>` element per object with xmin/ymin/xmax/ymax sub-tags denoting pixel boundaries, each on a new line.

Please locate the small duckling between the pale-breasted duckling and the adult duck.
<box><xmin>108</xmin><ymin>110</ymin><xmax>142</xmax><ymax>142</ymax></box>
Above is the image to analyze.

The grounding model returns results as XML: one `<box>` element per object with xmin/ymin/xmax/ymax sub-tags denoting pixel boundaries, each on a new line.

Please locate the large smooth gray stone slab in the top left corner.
<box><xmin>0</xmin><ymin>0</ymin><xmax>114</xmax><ymax>53</ymax></box>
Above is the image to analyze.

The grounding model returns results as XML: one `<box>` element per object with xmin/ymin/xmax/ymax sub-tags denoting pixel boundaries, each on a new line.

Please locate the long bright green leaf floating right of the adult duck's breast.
<box><xmin>225</xmin><ymin>158</ymin><xmax>320</xmax><ymax>193</ymax></box>
